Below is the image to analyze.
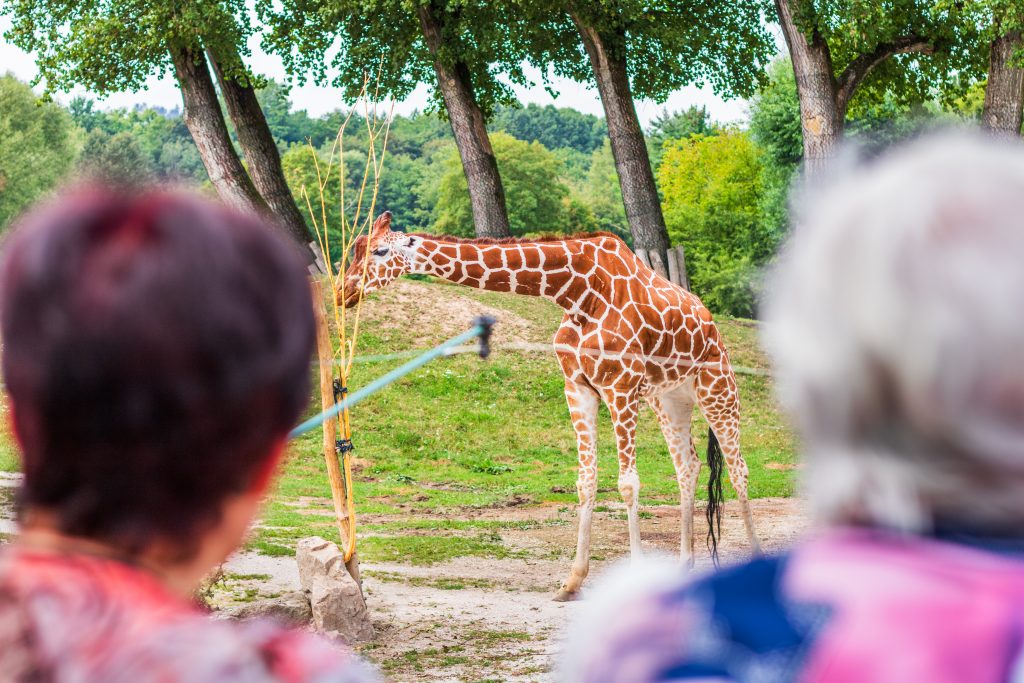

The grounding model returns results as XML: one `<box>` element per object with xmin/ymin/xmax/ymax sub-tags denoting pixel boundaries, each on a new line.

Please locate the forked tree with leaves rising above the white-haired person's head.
<box><xmin>775</xmin><ymin>0</ymin><xmax>980</xmax><ymax>175</ymax></box>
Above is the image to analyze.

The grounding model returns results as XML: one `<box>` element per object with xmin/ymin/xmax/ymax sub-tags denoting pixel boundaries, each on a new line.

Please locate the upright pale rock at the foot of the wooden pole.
<box><xmin>295</xmin><ymin>537</ymin><xmax>374</xmax><ymax>643</ymax></box>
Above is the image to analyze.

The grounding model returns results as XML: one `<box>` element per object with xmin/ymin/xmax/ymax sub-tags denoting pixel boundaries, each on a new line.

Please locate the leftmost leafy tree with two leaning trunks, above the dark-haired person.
<box><xmin>0</xmin><ymin>0</ymin><xmax>312</xmax><ymax>260</ymax></box>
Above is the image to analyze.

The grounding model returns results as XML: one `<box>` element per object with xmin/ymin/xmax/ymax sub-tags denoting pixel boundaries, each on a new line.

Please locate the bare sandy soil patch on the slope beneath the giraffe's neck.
<box><xmin>359</xmin><ymin>280</ymin><xmax>550</xmax><ymax>347</ymax></box>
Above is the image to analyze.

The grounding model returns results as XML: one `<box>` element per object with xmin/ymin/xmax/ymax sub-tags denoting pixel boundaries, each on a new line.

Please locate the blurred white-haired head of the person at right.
<box><xmin>765</xmin><ymin>133</ymin><xmax>1024</xmax><ymax>533</ymax></box>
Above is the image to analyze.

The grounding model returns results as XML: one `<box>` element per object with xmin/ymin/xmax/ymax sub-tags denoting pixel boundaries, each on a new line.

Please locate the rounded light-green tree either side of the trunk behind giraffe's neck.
<box><xmin>433</xmin><ymin>133</ymin><xmax>572</xmax><ymax>237</ymax></box>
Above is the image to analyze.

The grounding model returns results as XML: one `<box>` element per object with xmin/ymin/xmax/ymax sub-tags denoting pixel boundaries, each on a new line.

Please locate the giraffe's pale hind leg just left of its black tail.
<box><xmin>647</xmin><ymin>382</ymin><xmax>700</xmax><ymax>568</ymax></box>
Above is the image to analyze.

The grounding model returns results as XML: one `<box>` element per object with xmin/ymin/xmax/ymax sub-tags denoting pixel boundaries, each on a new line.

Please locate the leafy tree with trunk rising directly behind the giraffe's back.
<box><xmin>517</xmin><ymin>0</ymin><xmax>773</xmax><ymax>262</ymax></box>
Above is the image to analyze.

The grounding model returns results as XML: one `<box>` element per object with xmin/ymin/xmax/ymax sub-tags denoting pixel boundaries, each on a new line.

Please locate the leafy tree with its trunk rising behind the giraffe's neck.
<box><xmin>257</xmin><ymin>0</ymin><xmax>526</xmax><ymax>237</ymax></box>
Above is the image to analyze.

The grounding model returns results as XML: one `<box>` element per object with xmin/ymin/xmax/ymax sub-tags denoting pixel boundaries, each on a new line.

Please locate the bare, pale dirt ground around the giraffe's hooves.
<box><xmin>224</xmin><ymin>499</ymin><xmax>807</xmax><ymax>681</ymax></box>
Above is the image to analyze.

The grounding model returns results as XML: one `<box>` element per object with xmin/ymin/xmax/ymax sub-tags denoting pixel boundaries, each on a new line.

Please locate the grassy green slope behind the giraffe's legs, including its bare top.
<box><xmin>250</xmin><ymin>280</ymin><xmax>795</xmax><ymax>561</ymax></box>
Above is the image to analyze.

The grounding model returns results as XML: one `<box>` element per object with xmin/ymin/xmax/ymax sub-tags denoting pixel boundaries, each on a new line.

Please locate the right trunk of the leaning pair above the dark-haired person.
<box><xmin>209</xmin><ymin>46</ymin><xmax>313</xmax><ymax>255</ymax></box>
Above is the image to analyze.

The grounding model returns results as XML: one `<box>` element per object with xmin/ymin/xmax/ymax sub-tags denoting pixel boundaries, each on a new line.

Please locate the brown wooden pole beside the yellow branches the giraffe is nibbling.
<box><xmin>310</xmin><ymin>279</ymin><xmax>361</xmax><ymax>586</ymax></box>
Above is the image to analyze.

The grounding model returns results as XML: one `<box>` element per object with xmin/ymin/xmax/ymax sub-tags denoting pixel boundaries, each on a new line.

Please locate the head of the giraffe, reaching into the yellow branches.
<box><xmin>337</xmin><ymin>211</ymin><xmax>417</xmax><ymax>308</ymax></box>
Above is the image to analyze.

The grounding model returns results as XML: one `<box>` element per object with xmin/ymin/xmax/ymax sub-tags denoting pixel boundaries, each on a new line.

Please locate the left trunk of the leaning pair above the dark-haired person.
<box><xmin>171</xmin><ymin>47</ymin><xmax>269</xmax><ymax>214</ymax></box>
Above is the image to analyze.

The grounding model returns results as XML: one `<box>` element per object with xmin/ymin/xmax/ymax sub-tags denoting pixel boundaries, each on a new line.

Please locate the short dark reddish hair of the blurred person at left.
<box><xmin>0</xmin><ymin>188</ymin><xmax>315</xmax><ymax>554</ymax></box>
